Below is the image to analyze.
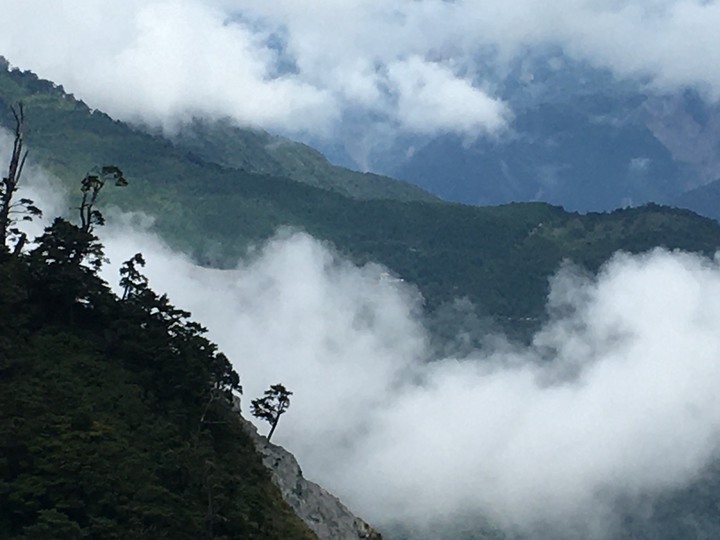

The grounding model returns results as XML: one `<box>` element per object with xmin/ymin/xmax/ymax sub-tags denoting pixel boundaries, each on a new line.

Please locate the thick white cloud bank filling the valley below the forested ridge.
<box><xmin>8</xmin><ymin>130</ymin><xmax>720</xmax><ymax>538</ymax></box>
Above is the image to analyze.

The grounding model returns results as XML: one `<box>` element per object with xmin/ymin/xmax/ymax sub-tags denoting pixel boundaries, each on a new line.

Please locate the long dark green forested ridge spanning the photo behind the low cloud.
<box><xmin>0</xmin><ymin>64</ymin><xmax>720</xmax><ymax>333</ymax></box>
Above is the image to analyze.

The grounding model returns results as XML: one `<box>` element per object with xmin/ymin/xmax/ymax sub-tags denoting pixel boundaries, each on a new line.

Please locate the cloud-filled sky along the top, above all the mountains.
<box><xmin>0</xmin><ymin>0</ymin><xmax>720</xmax><ymax>148</ymax></box>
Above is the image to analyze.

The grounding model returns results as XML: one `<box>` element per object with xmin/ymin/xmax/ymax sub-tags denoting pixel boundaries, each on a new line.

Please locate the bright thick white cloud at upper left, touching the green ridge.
<box><xmin>0</xmin><ymin>1</ymin><xmax>338</xmax><ymax>132</ymax></box>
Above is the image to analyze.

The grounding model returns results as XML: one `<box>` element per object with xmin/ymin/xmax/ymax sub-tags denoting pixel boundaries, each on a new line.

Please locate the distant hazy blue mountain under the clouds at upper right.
<box><xmin>378</xmin><ymin>56</ymin><xmax>720</xmax><ymax>211</ymax></box>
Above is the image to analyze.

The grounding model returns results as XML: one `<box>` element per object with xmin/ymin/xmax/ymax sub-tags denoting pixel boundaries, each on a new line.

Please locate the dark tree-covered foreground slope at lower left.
<box><xmin>0</xmin><ymin>195</ymin><xmax>315</xmax><ymax>540</ymax></box>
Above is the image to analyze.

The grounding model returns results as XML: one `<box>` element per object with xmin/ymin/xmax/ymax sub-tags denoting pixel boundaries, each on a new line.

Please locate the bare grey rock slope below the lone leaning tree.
<box><xmin>244</xmin><ymin>421</ymin><xmax>382</xmax><ymax>540</ymax></box>
